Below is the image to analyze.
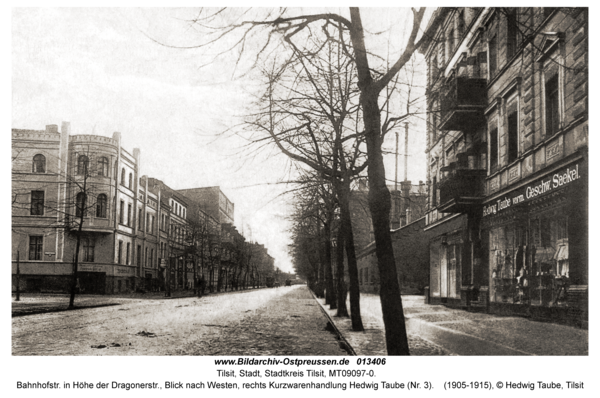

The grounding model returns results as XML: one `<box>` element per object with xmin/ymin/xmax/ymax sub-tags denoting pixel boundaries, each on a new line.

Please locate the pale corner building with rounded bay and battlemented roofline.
<box><xmin>12</xmin><ymin>122</ymin><xmax>143</xmax><ymax>293</ymax></box>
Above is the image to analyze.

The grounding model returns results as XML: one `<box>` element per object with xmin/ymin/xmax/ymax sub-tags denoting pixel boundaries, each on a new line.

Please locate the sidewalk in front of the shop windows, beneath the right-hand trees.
<box><xmin>317</xmin><ymin>294</ymin><xmax>588</xmax><ymax>355</ymax></box>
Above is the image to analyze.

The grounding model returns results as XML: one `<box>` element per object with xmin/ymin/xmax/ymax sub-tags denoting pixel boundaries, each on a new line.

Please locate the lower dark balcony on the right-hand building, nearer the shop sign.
<box><xmin>438</xmin><ymin>164</ymin><xmax>487</xmax><ymax>213</ymax></box>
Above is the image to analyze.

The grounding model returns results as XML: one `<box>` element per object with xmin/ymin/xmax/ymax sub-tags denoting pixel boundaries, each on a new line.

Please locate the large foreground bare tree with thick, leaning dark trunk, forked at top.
<box><xmin>146</xmin><ymin>8</ymin><xmax>425</xmax><ymax>355</ymax></box>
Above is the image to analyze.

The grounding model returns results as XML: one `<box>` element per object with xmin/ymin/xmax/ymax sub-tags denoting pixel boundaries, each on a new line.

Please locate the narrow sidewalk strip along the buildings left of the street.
<box><xmin>12</xmin><ymin>289</ymin><xmax>264</xmax><ymax>317</ymax></box>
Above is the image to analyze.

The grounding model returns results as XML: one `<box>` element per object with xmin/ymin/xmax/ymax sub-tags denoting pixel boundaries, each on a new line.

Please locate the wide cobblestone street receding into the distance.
<box><xmin>12</xmin><ymin>286</ymin><xmax>346</xmax><ymax>355</ymax></box>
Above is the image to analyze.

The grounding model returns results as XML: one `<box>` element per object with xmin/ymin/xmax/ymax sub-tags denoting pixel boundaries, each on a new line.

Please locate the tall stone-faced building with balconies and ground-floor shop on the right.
<box><xmin>420</xmin><ymin>7</ymin><xmax>588</xmax><ymax>324</ymax></box>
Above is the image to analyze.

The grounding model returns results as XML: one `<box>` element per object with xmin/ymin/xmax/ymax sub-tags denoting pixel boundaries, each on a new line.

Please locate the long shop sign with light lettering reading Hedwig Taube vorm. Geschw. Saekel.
<box><xmin>483</xmin><ymin>164</ymin><xmax>581</xmax><ymax>217</ymax></box>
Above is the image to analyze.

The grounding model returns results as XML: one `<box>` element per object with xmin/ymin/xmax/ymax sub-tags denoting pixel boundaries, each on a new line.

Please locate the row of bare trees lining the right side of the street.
<box><xmin>158</xmin><ymin>8</ymin><xmax>432</xmax><ymax>355</ymax></box>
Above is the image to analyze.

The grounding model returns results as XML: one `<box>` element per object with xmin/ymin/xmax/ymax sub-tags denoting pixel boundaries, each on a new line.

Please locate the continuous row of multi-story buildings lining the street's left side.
<box><xmin>12</xmin><ymin>123</ymin><xmax>272</xmax><ymax>294</ymax></box>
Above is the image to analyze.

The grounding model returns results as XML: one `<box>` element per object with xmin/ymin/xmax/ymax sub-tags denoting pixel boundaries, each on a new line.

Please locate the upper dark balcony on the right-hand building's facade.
<box><xmin>439</xmin><ymin>77</ymin><xmax>487</xmax><ymax>131</ymax></box>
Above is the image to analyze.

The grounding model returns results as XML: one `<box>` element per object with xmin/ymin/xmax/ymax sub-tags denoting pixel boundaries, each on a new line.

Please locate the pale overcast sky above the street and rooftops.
<box><xmin>12</xmin><ymin>8</ymin><xmax>426</xmax><ymax>271</ymax></box>
